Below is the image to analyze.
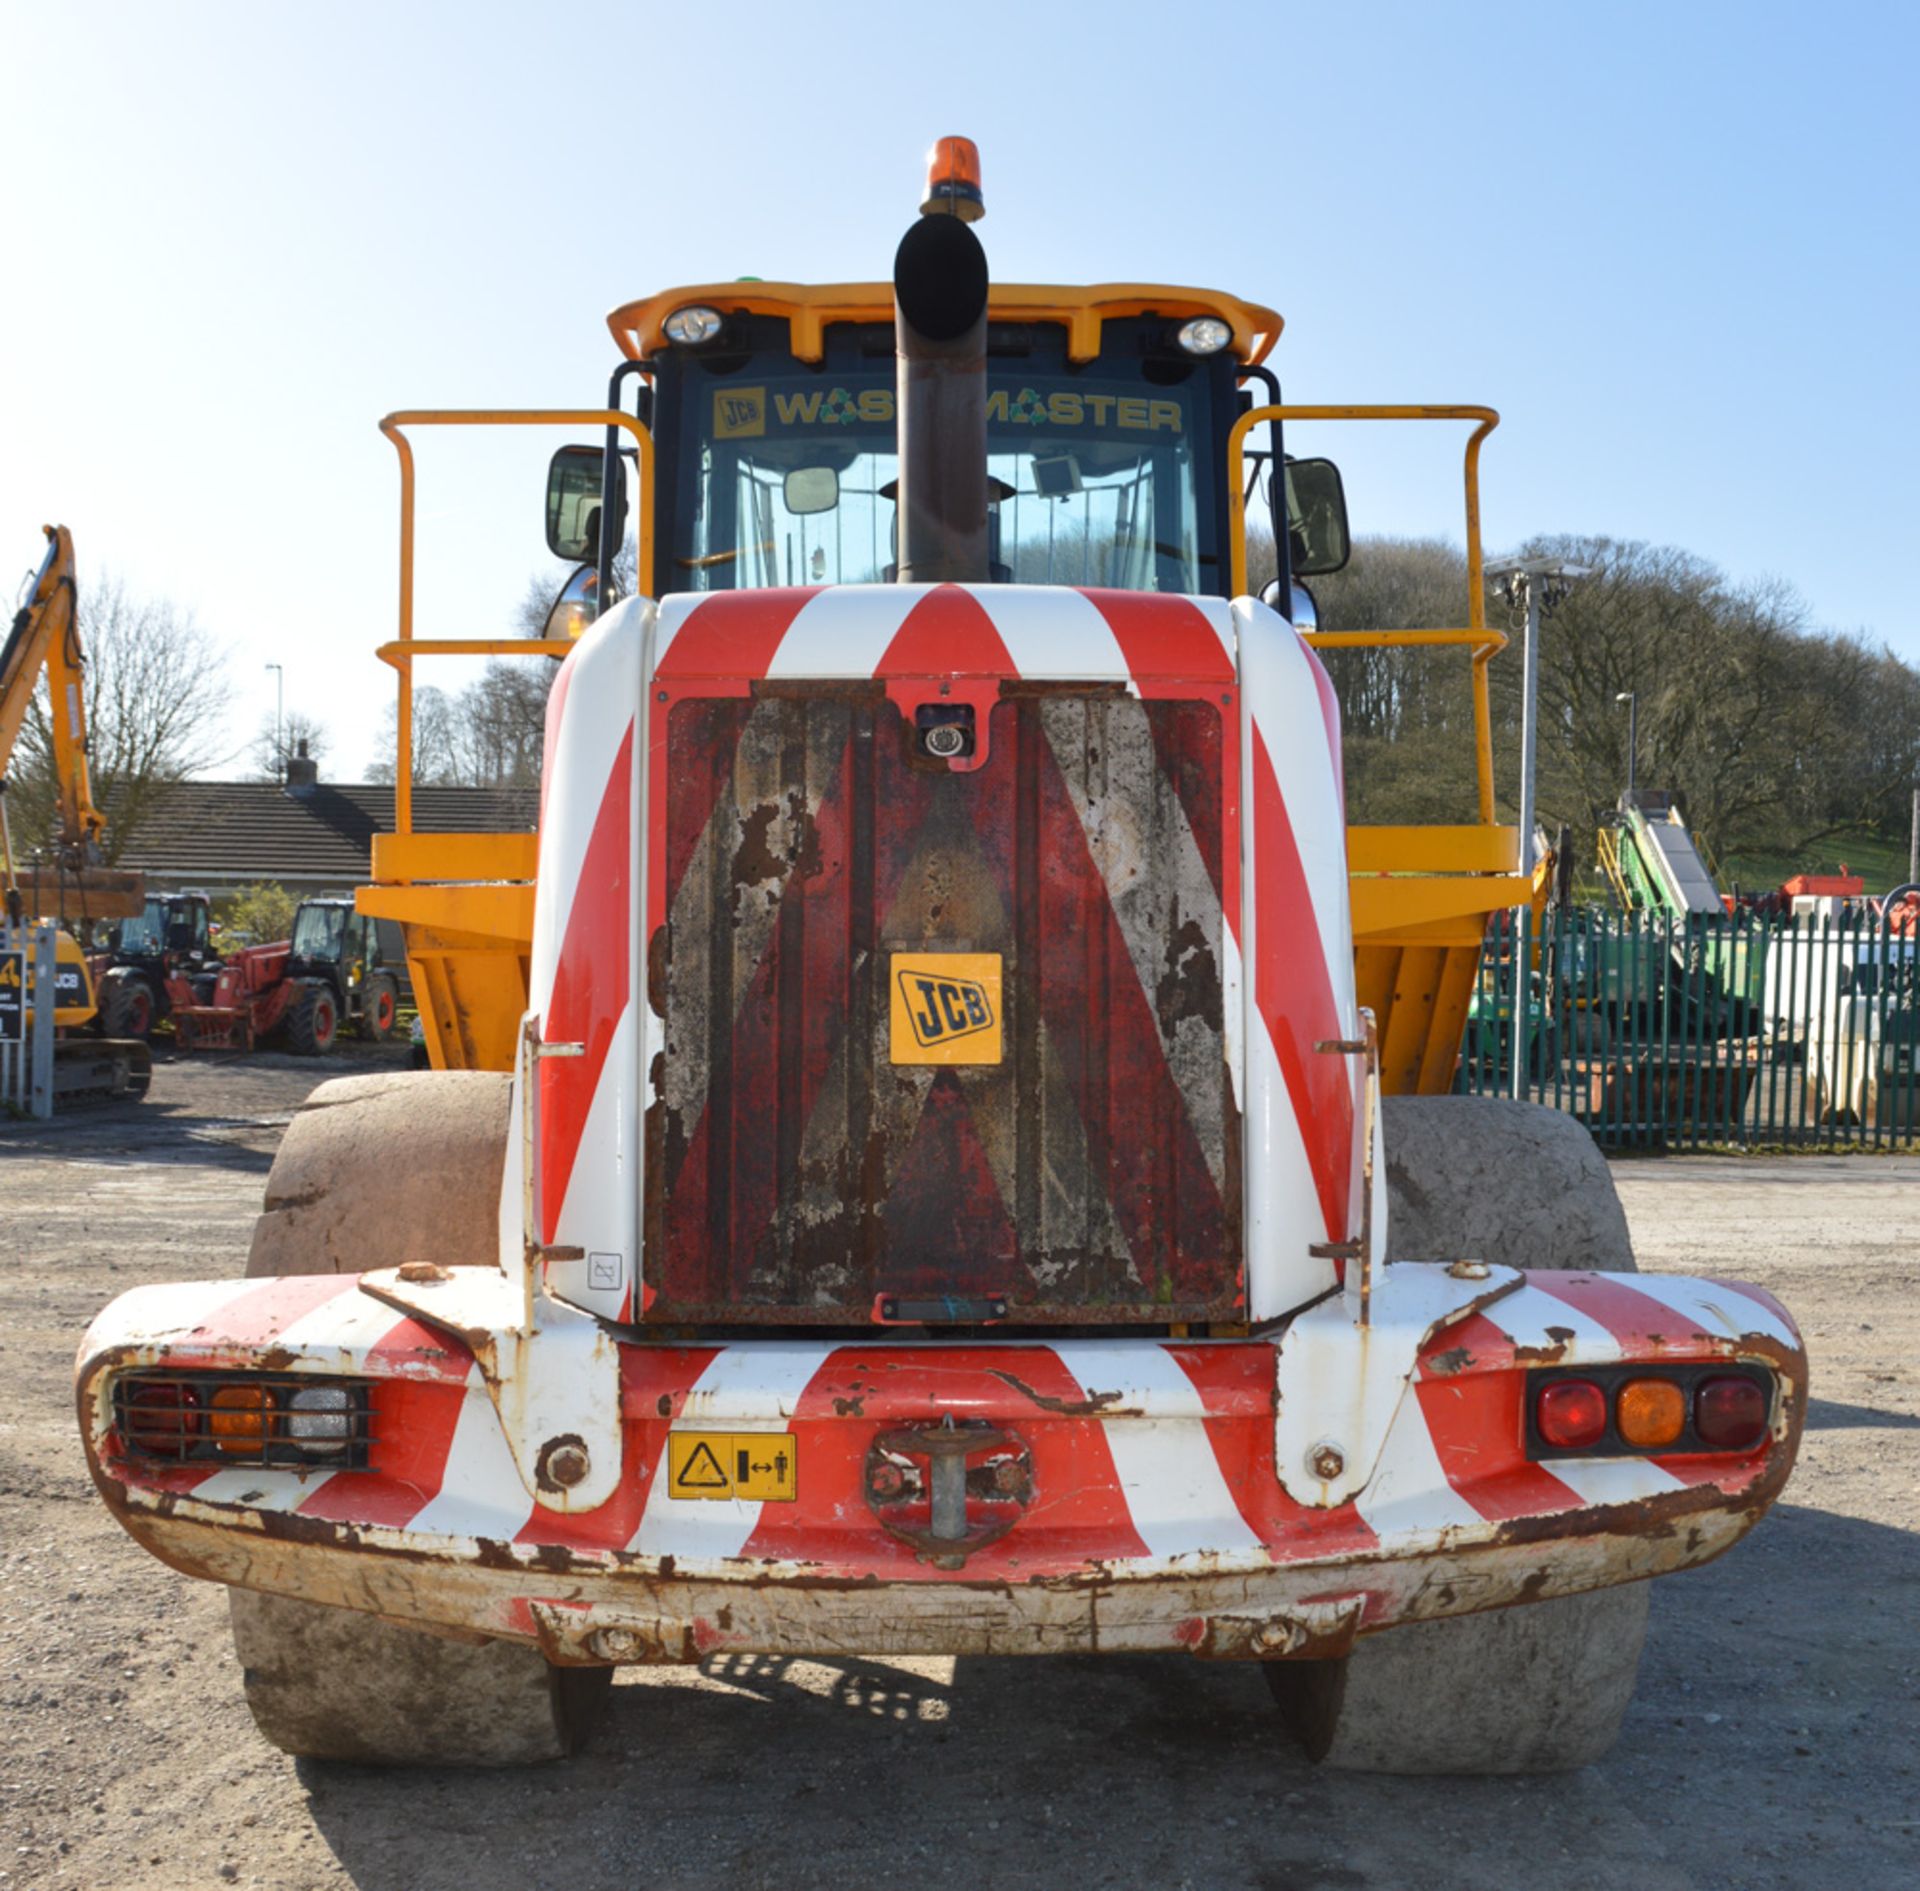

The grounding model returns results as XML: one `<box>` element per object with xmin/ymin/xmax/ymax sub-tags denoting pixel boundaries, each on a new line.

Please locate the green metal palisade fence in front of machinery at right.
<box><xmin>1455</xmin><ymin>908</ymin><xmax>1920</xmax><ymax>1148</ymax></box>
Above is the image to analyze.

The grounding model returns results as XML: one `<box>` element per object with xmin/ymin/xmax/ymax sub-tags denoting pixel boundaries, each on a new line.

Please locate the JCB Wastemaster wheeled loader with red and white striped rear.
<box><xmin>79</xmin><ymin>140</ymin><xmax>1805</xmax><ymax>1772</ymax></box>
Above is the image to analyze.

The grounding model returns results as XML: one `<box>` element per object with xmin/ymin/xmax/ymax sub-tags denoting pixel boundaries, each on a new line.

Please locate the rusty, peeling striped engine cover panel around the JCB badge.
<box><xmin>645</xmin><ymin>680</ymin><xmax>1244</xmax><ymax>1323</ymax></box>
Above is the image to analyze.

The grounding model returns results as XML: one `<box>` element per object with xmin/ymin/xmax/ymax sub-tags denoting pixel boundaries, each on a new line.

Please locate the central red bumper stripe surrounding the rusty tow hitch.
<box><xmin>741</xmin><ymin>1346</ymin><xmax>1144</xmax><ymax>1582</ymax></box>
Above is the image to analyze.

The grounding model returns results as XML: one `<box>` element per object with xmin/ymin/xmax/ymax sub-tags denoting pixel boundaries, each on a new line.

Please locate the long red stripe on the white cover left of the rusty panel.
<box><xmin>538</xmin><ymin>724</ymin><xmax>634</xmax><ymax>1242</ymax></box>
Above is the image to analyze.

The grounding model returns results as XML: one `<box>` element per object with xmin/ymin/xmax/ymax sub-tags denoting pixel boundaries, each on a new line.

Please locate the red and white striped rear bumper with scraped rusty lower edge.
<box><xmin>79</xmin><ymin>1267</ymin><xmax>1805</xmax><ymax>1661</ymax></box>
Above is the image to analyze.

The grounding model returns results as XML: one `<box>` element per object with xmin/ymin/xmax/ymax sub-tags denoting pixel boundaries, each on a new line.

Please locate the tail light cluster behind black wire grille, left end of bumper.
<box><xmin>113</xmin><ymin>1371</ymin><xmax>374</xmax><ymax>1471</ymax></box>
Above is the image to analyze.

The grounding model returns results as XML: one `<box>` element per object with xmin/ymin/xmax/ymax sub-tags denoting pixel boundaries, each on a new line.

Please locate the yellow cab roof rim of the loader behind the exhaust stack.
<box><xmin>607</xmin><ymin>278</ymin><xmax>1281</xmax><ymax>365</ymax></box>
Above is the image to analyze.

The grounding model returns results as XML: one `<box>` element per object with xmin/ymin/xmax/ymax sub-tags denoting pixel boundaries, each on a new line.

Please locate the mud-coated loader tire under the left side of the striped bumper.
<box><xmin>228</xmin><ymin>1071</ymin><xmax>612</xmax><ymax>1766</ymax></box>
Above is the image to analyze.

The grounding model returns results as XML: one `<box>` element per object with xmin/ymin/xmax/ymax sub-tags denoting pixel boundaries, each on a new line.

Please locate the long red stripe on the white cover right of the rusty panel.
<box><xmin>1254</xmin><ymin>726</ymin><xmax>1354</xmax><ymax>1240</ymax></box>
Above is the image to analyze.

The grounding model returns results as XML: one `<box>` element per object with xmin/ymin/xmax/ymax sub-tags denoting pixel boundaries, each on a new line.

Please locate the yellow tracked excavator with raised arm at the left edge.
<box><xmin>0</xmin><ymin>526</ymin><xmax>154</xmax><ymax>1106</ymax></box>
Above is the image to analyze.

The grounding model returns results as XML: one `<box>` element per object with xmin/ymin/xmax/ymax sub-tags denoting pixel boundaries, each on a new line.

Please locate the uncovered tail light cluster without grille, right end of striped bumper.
<box><xmin>1526</xmin><ymin>1365</ymin><xmax>1774</xmax><ymax>1459</ymax></box>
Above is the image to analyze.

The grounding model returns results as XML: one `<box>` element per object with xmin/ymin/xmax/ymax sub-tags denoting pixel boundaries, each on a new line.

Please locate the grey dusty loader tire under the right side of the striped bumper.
<box><xmin>1267</xmin><ymin>1096</ymin><xmax>1647</xmax><ymax>1774</ymax></box>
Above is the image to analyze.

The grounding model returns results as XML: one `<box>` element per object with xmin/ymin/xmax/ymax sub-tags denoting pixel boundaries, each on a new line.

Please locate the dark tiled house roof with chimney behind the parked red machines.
<box><xmin>119</xmin><ymin>754</ymin><xmax>540</xmax><ymax>898</ymax></box>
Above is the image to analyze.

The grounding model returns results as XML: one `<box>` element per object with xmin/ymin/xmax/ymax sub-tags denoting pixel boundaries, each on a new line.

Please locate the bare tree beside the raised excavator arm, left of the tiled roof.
<box><xmin>10</xmin><ymin>576</ymin><xmax>230</xmax><ymax>866</ymax></box>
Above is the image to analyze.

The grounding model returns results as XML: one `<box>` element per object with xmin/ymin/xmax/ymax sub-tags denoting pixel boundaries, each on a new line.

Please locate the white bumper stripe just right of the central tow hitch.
<box><xmin>1052</xmin><ymin>1340</ymin><xmax>1265</xmax><ymax>1557</ymax></box>
